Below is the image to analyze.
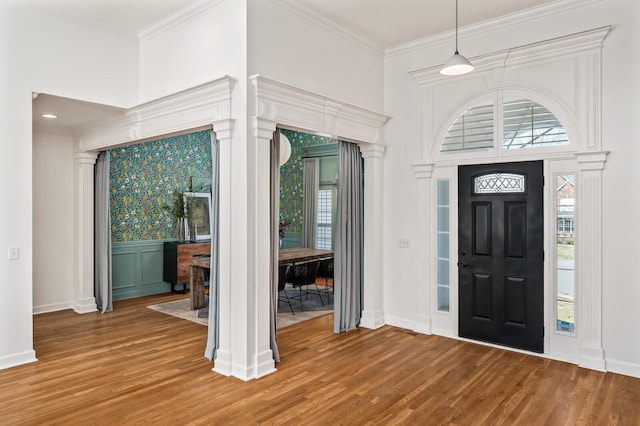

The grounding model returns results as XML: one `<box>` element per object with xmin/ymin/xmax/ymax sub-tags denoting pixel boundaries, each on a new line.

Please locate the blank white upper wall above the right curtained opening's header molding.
<box><xmin>249</xmin><ymin>0</ymin><xmax>383</xmax><ymax>111</ymax></box>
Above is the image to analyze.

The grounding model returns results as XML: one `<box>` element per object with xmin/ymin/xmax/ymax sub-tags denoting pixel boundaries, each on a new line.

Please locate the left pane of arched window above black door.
<box><xmin>440</xmin><ymin>105</ymin><xmax>494</xmax><ymax>152</ymax></box>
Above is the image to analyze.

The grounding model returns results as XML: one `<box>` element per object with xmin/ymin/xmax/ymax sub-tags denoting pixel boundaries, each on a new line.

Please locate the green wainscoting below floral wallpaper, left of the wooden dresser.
<box><xmin>111</xmin><ymin>240</ymin><xmax>171</xmax><ymax>300</ymax></box>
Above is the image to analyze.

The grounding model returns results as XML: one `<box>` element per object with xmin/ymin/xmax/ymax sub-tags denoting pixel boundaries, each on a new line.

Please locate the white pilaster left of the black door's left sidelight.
<box><xmin>413</xmin><ymin>163</ymin><xmax>436</xmax><ymax>334</ymax></box>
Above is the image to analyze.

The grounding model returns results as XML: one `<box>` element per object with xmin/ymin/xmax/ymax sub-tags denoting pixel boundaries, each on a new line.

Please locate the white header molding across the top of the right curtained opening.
<box><xmin>249</xmin><ymin>75</ymin><xmax>390</xmax><ymax>143</ymax></box>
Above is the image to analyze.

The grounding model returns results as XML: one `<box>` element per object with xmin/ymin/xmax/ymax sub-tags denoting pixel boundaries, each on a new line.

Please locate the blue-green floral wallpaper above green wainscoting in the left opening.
<box><xmin>109</xmin><ymin>130</ymin><xmax>212</xmax><ymax>242</ymax></box>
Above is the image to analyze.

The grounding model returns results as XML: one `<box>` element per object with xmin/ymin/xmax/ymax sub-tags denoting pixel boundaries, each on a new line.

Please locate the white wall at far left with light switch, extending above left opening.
<box><xmin>0</xmin><ymin>1</ymin><xmax>138</xmax><ymax>368</ymax></box>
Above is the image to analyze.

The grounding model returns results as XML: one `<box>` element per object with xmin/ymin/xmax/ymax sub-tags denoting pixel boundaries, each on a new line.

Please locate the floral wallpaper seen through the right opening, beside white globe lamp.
<box><xmin>280</xmin><ymin>129</ymin><xmax>338</xmax><ymax>232</ymax></box>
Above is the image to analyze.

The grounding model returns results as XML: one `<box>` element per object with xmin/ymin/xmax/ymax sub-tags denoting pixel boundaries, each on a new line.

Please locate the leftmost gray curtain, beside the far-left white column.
<box><xmin>94</xmin><ymin>151</ymin><xmax>113</xmax><ymax>314</ymax></box>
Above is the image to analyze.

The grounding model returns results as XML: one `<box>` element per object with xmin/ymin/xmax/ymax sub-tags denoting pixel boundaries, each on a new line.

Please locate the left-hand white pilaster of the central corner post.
<box><xmin>213</xmin><ymin>120</ymin><xmax>234</xmax><ymax>376</ymax></box>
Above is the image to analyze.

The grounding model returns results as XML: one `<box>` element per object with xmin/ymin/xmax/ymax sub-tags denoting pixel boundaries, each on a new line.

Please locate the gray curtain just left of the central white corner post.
<box><xmin>204</xmin><ymin>132</ymin><xmax>220</xmax><ymax>361</ymax></box>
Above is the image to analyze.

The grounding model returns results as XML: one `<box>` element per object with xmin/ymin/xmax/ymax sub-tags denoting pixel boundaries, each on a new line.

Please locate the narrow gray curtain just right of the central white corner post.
<box><xmin>269</xmin><ymin>129</ymin><xmax>280</xmax><ymax>362</ymax></box>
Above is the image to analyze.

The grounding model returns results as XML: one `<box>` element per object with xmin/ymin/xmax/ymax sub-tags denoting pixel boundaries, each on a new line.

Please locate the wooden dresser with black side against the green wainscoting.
<box><xmin>162</xmin><ymin>241</ymin><xmax>211</xmax><ymax>293</ymax></box>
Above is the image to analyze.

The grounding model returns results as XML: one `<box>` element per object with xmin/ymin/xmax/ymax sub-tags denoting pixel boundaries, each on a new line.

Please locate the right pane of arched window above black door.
<box><xmin>502</xmin><ymin>99</ymin><xmax>569</xmax><ymax>149</ymax></box>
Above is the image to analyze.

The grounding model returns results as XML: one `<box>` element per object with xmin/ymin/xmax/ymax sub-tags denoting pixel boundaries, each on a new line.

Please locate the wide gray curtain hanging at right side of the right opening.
<box><xmin>333</xmin><ymin>142</ymin><xmax>364</xmax><ymax>333</ymax></box>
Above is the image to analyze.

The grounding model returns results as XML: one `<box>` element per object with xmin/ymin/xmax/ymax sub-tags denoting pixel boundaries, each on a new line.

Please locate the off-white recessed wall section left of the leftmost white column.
<box><xmin>33</xmin><ymin>131</ymin><xmax>75</xmax><ymax>313</ymax></box>
